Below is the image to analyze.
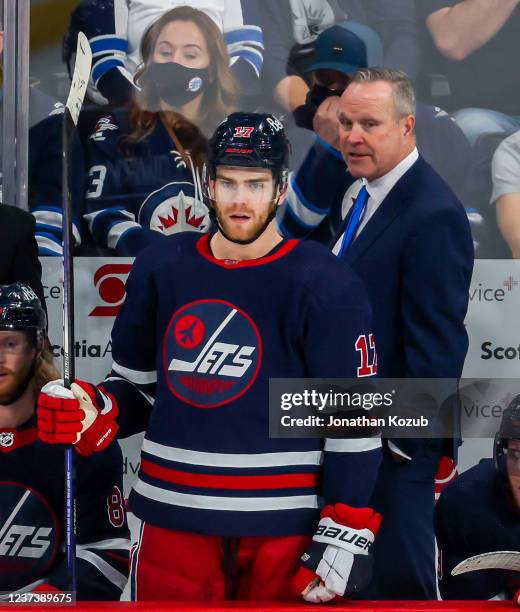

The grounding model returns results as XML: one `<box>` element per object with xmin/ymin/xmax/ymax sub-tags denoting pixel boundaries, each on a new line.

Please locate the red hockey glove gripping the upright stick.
<box><xmin>37</xmin><ymin>380</ymin><xmax>119</xmax><ymax>455</ymax></box>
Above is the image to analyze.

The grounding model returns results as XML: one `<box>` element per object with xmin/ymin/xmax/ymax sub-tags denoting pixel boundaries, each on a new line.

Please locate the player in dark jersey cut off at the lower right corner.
<box><xmin>435</xmin><ymin>395</ymin><xmax>520</xmax><ymax>599</ymax></box>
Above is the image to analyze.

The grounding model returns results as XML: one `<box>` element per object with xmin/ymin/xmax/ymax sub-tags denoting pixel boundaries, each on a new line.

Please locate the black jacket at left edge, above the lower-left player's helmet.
<box><xmin>0</xmin><ymin>204</ymin><xmax>45</xmax><ymax>308</ymax></box>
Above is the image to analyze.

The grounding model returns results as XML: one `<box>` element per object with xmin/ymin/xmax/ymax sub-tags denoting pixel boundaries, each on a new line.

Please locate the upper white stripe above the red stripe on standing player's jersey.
<box><xmin>143</xmin><ymin>438</ymin><xmax>322</xmax><ymax>468</ymax></box>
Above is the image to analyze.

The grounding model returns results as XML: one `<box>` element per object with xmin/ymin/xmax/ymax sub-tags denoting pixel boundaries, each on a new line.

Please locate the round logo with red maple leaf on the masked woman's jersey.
<box><xmin>138</xmin><ymin>183</ymin><xmax>210</xmax><ymax>236</ymax></box>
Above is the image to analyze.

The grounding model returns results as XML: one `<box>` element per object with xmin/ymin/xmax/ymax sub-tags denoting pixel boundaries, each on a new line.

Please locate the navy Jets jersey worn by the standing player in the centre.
<box><xmin>97</xmin><ymin>233</ymin><xmax>381</xmax><ymax>536</ymax></box>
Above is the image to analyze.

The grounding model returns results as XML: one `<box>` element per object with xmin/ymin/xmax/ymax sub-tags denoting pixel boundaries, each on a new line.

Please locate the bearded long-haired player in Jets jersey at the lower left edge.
<box><xmin>0</xmin><ymin>283</ymin><xmax>129</xmax><ymax>600</ymax></box>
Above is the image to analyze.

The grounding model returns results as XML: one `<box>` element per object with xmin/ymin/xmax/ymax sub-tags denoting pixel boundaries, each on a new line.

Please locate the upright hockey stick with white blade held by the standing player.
<box><xmin>62</xmin><ymin>32</ymin><xmax>92</xmax><ymax>594</ymax></box>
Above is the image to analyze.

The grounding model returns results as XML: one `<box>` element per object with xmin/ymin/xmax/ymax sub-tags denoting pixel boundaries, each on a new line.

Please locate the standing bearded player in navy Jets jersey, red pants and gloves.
<box><xmin>39</xmin><ymin>113</ymin><xmax>381</xmax><ymax>602</ymax></box>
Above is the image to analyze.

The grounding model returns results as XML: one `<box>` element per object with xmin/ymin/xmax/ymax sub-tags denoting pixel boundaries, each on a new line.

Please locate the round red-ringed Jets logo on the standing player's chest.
<box><xmin>163</xmin><ymin>300</ymin><xmax>262</xmax><ymax>408</ymax></box>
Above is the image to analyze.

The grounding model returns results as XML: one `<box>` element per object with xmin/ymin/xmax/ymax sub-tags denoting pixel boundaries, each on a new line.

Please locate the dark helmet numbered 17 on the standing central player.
<box><xmin>208</xmin><ymin>113</ymin><xmax>289</xmax><ymax>176</ymax></box>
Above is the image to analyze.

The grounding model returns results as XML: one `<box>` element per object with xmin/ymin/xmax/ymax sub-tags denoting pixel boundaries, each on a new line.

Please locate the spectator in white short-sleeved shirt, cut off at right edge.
<box><xmin>491</xmin><ymin>131</ymin><xmax>520</xmax><ymax>259</ymax></box>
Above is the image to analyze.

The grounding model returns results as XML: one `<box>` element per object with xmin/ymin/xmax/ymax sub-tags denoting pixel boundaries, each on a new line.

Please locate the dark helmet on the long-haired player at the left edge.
<box><xmin>0</xmin><ymin>283</ymin><xmax>47</xmax><ymax>348</ymax></box>
